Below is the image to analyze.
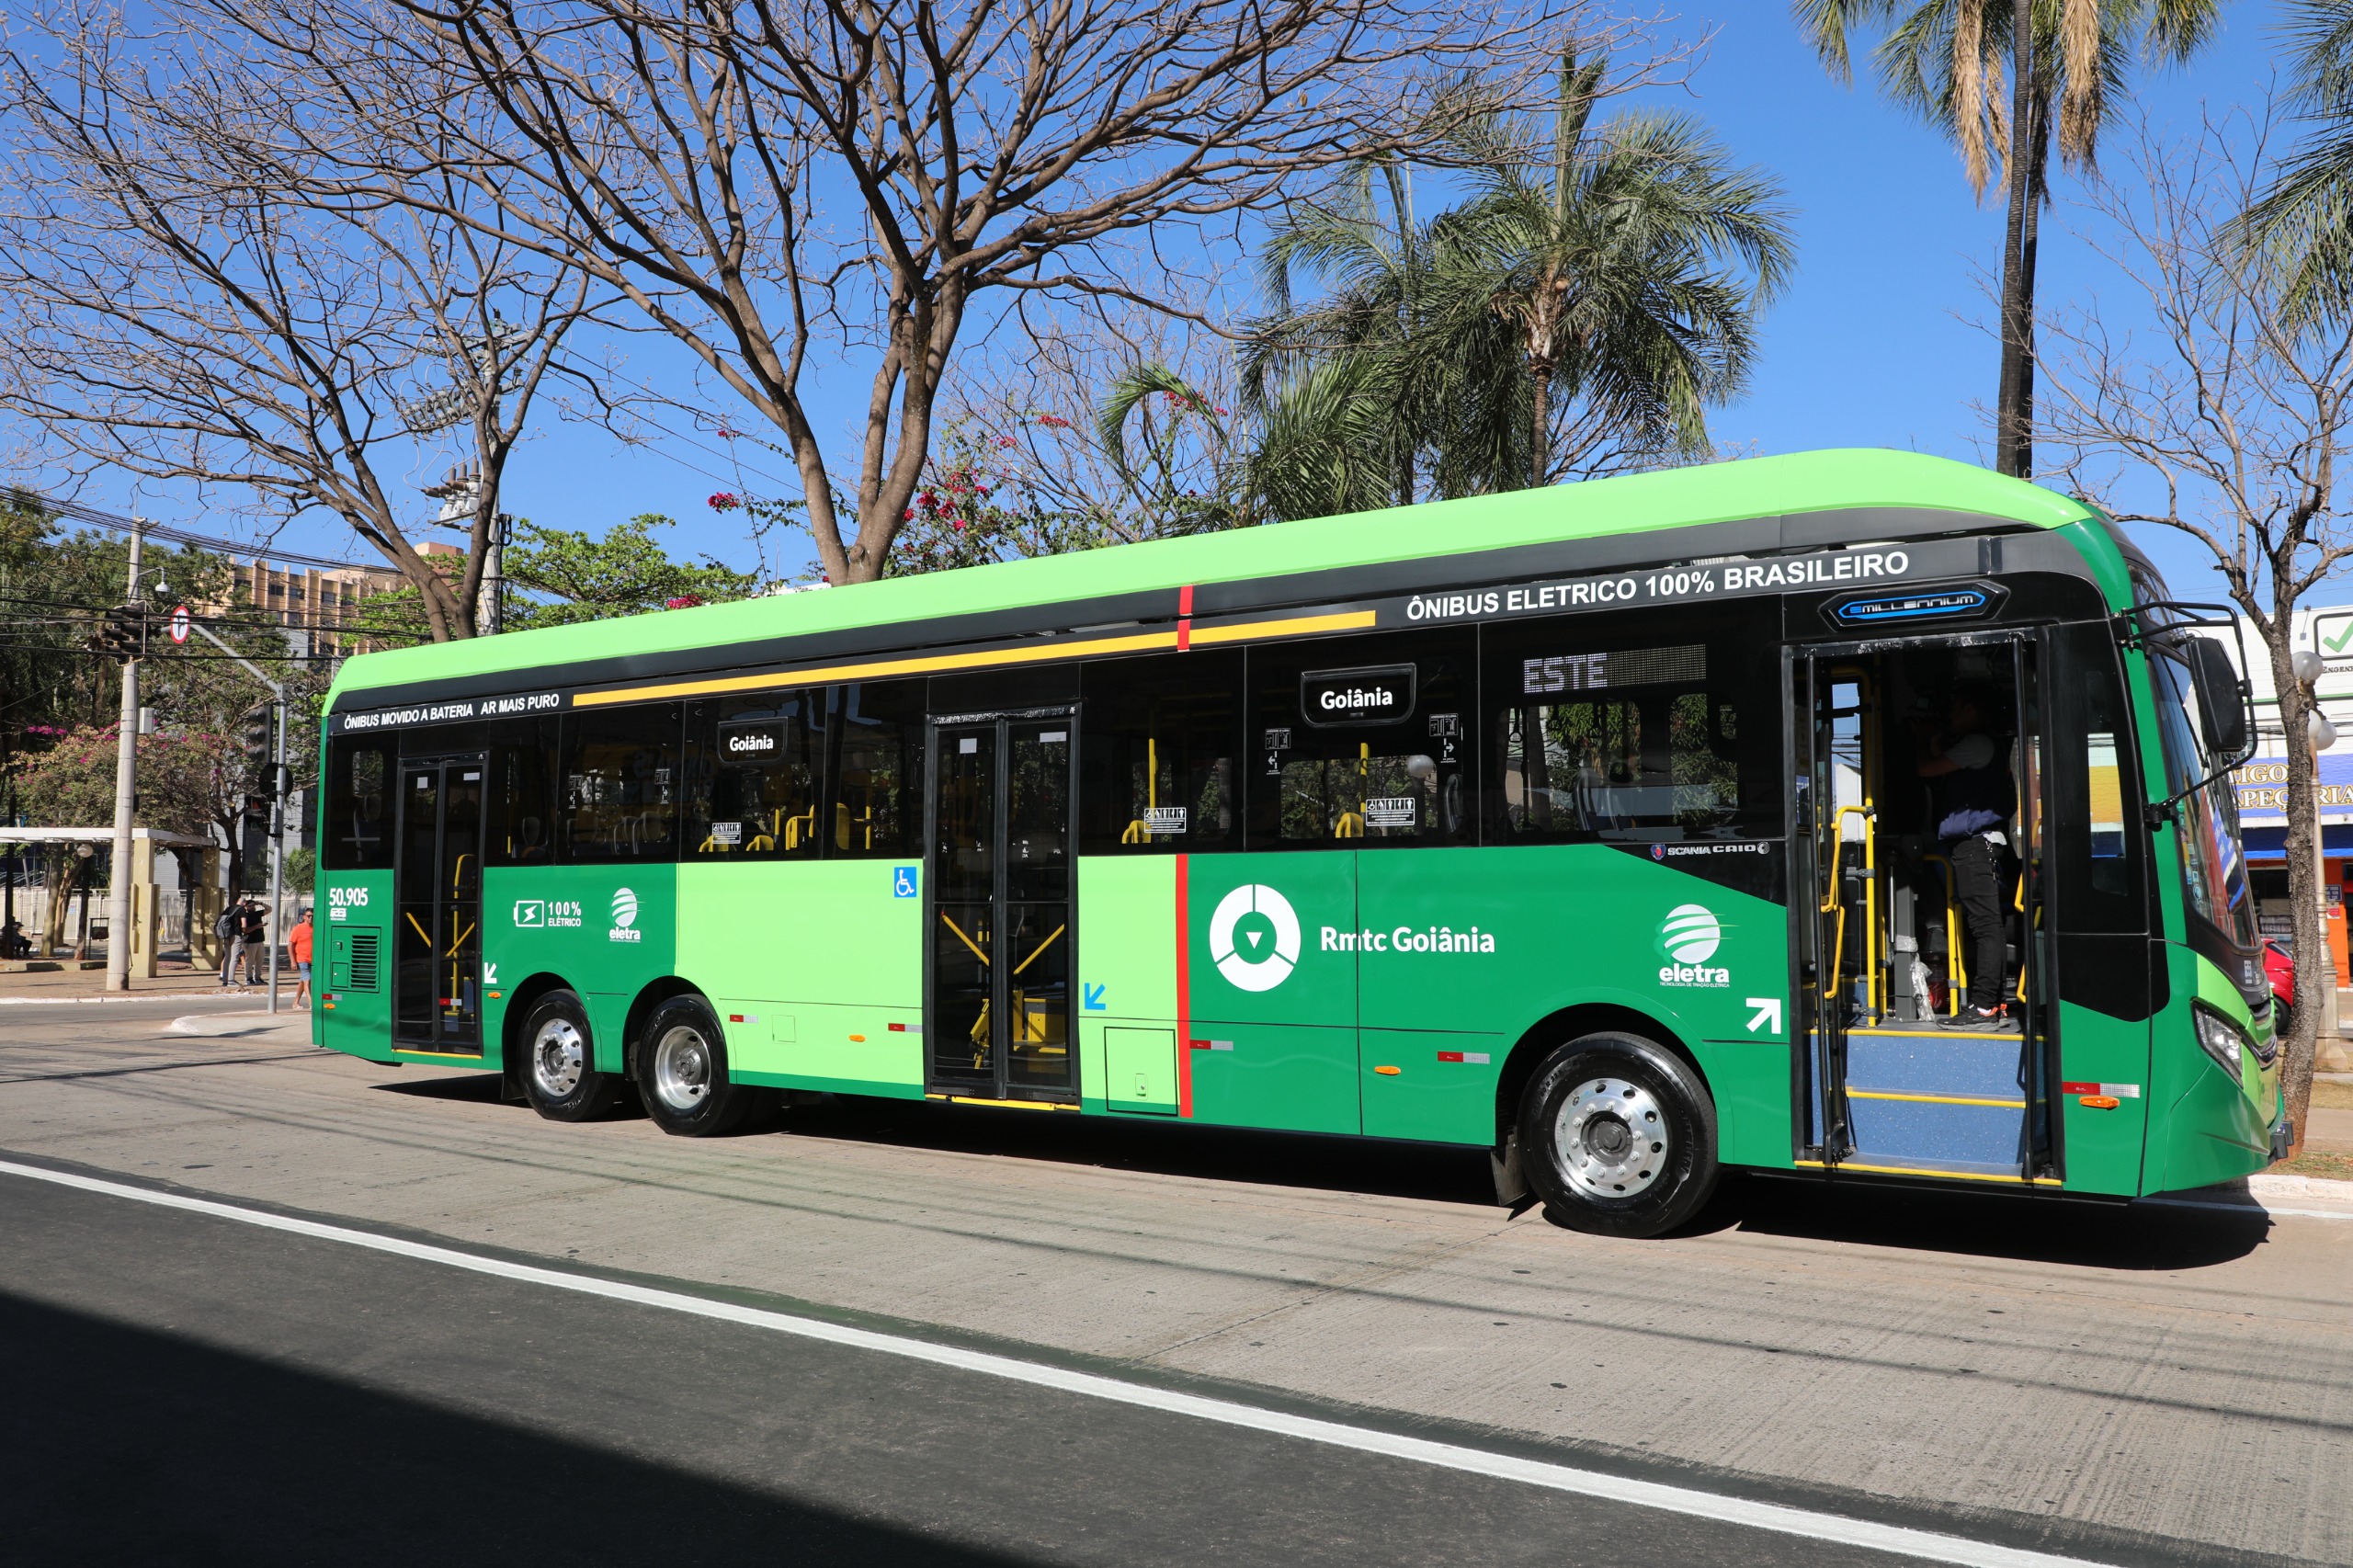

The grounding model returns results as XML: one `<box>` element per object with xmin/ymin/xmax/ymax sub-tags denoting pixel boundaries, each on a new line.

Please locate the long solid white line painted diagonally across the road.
<box><xmin>0</xmin><ymin>1161</ymin><xmax>2118</xmax><ymax>1568</ymax></box>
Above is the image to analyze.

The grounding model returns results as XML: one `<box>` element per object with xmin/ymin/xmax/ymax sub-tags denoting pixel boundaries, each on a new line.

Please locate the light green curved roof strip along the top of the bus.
<box><xmin>335</xmin><ymin>448</ymin><xmax>2099</xmax><ymax>695</ymax></box>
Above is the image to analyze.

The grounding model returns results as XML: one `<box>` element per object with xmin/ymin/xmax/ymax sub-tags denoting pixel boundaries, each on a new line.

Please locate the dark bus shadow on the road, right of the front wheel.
<box><xmin>1722</xmin><ymin>1173</ymin><xmax>2270</xmax><ymax>1274</ymax></box>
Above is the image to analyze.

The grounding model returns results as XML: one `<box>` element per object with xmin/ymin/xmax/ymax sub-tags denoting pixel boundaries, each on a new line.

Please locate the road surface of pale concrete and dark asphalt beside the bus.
<box><xmin>0</xmin><ymin>1003</ymin><xmax>2353</xmax><ymax>1568</ymax></box>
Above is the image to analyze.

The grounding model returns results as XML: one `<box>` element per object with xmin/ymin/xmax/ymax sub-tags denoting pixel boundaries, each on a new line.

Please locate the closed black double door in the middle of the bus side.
<box><xmin>925</xmin><ymin>711</ymin><xmax>1077</xmax><ymax>1104</ymax></box>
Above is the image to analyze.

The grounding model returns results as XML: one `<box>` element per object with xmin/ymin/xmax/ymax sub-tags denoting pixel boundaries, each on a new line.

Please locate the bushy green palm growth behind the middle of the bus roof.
<box><xmin>1245</xmin><ymin>56</ymin><xmax>1793</xmax><ymax>516</ymax></box>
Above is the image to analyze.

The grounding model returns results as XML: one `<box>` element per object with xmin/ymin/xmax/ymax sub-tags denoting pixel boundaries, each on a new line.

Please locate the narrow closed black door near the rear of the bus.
<box><xmin>393</xmin><ymin>756</ymin><xmax>483</xmax><ymax>1057</ymax></box>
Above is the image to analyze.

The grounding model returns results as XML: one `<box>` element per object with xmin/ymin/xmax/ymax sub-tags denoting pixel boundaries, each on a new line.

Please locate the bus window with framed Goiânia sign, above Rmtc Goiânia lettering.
<box><xmin>1247</xmin><ymin>631</ymin><xmax>1478</xmax><ymax>850</ymax></box>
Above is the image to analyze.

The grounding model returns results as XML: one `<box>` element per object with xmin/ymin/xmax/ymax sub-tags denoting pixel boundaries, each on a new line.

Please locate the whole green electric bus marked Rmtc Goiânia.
<box><xmin>315</xmin><ymin>452</ymin><xmax>2285</xmax><ymax>1236</ymax></box>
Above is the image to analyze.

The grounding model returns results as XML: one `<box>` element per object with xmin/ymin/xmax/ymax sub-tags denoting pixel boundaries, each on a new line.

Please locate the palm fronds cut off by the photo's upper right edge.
<box><xmin>2245</xmin><ymin>0</ymin><xmax>2353</xmax><ymax>324</ymax></box>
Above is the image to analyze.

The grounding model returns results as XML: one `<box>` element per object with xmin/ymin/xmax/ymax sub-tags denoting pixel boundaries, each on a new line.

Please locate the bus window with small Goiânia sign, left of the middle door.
<box><xmin>680</xmin><ymin>692</ymin><xmax>824</xmax><ymax>862</ymax></box>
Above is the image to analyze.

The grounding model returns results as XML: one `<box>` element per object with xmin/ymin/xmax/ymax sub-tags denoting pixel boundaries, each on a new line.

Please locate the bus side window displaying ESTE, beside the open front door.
<box><xmin>1484</xmin><ymin>605</ymin><xmax>1781</xmax><ymax>843</ymax></box>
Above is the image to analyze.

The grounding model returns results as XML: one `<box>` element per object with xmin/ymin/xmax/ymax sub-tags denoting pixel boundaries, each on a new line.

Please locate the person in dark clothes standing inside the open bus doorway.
<box><xmin>1917</xmin><ymin>685</ymin><xmax>2018</xmax><ymax>1028</ymax></box>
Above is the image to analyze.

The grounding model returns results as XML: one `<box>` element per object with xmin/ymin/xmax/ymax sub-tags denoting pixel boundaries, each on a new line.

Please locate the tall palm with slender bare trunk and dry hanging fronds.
<box><xmin>1790</xmin><ymin>0</ymin><xmax>2222</xmax><ymax>478</ymax></box>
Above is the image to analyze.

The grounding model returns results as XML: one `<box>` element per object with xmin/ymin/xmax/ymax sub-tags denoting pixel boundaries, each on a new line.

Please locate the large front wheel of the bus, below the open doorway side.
<box><xmin>1520</xmin><ymin>1031</ymin><xmax>1718</xmax><ymax>1236</ymax></box>
